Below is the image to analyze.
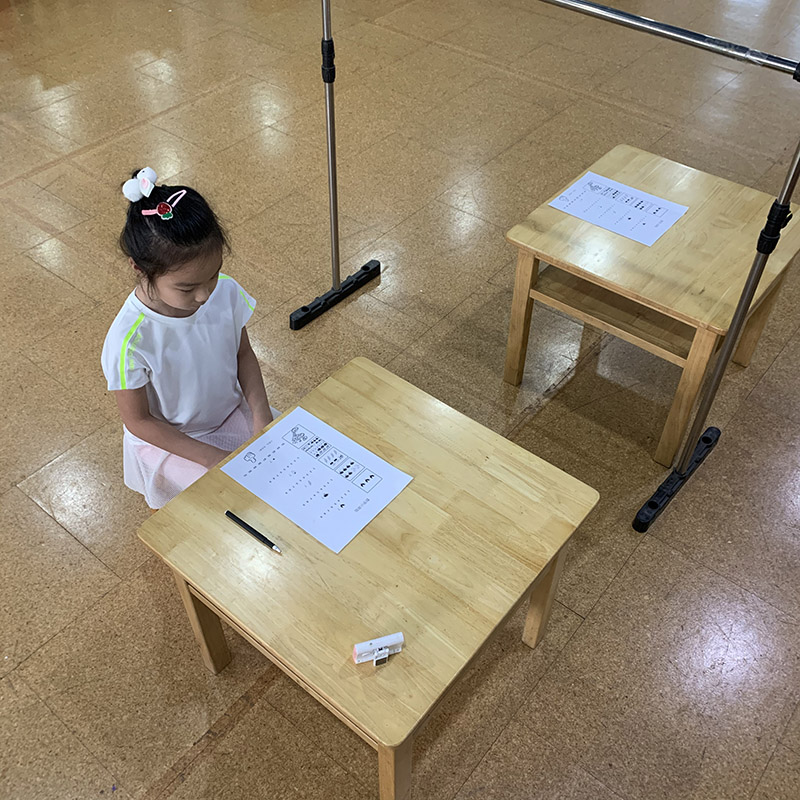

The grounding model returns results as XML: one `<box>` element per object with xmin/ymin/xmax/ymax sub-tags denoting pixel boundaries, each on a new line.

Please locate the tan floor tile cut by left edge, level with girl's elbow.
<box><xmin>0</xmin><ymin>352</ymin><xmax>107</xmax><ymax>487</ymax></box>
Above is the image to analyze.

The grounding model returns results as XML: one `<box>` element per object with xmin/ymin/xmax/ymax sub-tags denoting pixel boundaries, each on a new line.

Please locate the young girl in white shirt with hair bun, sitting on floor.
<box><xmin>102</xmin><ymin>167</ymin><xmax>272</xmax><ymax>509</ymax></box>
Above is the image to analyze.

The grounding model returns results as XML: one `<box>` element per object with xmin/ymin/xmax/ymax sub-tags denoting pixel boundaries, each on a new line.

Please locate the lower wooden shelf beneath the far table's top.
<box><xmin>531</xmin><ymin>266</ymin><xmax>695</xmax><ymax>366</ymax></box>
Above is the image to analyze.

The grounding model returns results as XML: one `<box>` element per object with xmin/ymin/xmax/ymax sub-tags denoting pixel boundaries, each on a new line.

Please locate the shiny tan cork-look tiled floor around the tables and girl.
<box><xmin>0</xmin><ymin>0</ymin><xmax>800</xmax><ymax>800</ymax></box>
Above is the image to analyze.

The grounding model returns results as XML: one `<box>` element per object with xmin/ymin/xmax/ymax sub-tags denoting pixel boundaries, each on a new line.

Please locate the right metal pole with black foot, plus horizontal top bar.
<box><xmin>544</xmin><ymin>0</ymin><xmax>800</xmax><ymax>533</ymax></box>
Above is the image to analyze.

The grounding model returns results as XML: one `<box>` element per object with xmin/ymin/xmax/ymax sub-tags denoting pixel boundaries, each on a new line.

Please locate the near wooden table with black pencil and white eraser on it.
<box><xmin>139</xmin><ymin>358</ymin><xmax>598</xmax><ymax>800</ymax></box>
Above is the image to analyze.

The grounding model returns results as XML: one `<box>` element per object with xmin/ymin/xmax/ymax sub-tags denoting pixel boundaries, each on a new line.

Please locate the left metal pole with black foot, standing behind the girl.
<box><xmin>289</xmin><ymin>0</ymin><xmax>381</xmax><ymax>331</ymax></box>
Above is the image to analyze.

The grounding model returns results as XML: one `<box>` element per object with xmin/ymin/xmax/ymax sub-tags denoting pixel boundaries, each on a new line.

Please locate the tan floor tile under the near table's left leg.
<box><xmin>19</xmin><ymin>559</ymin><xmax>272</xmax><ymax>795</ymax></box>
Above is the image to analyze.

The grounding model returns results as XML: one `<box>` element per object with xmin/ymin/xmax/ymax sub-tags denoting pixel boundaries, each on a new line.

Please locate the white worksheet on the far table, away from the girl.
<box><xmin>550</xmin><ymin>172</ymin><xmax>689</xmax><ymax>247</ymax></box>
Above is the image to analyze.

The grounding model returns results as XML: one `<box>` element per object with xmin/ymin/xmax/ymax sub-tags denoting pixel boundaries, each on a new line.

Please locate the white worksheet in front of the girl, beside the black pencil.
<box><xmin>222</xmin><ymin>408</ymin><xmax>411</xmax><ymax>553</ymax></box>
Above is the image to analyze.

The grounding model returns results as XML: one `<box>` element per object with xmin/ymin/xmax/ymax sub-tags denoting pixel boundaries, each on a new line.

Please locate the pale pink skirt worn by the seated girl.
<box><xmin>122</xmin><ymin>402</ymin><xmax>280</xmax><ymax>509</ymax></box>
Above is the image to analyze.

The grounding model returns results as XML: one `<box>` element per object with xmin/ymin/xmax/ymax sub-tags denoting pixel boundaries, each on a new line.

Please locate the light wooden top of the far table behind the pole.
<box><xmin>507</xmin><ymin>144</ymin><xmax>800</xmax><ymax>333</ymax></box>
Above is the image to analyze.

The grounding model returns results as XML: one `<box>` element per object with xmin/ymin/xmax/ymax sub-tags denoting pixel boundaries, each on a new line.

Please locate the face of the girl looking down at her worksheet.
<box><xmin>134</xmin><ymin>248</ymin><xmax>222</xmax><ymax>317</ymax></box>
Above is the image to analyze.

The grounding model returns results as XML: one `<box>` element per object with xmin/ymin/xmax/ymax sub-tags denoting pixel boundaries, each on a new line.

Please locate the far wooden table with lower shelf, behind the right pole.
<box><xmin>504</xmin><ymin>145</ymin><xmax>800</xmax><ymax>466</ymax></box>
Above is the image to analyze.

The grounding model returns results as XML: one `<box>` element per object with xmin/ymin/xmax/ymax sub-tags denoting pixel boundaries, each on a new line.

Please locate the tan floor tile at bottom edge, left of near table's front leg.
<box><xmin>169</xmin><ymin>688</ymin><xmax>368</xmax><ymax>800</ymax></box>
